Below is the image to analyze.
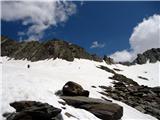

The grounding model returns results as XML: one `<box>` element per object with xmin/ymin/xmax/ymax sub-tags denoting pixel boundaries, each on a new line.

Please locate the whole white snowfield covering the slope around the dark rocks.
<box><xmin>0</xmin><ymin>57</ymin><xmax>160</xmax><ymax>120</ymax></box>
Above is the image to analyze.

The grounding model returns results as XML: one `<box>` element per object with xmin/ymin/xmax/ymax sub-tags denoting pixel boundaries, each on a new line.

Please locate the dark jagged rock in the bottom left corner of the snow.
<box><xmin>3</xmin><ymin>101</ymin><xmax>62</xmax><ymax>120</ymax></box>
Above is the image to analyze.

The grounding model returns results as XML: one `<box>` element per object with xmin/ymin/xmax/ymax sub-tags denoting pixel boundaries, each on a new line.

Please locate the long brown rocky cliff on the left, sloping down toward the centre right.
<box><xmin>1</xmin><ymin>36</ymin><xmax>103</xmax><ymax>62</ymax></box>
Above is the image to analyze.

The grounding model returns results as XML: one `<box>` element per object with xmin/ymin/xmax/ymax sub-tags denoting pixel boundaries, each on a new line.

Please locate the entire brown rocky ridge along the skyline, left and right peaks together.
<box><xmin>1</xmin><ymin>35</ymin><xmax>160</xmax><ymax>65</ymax></box>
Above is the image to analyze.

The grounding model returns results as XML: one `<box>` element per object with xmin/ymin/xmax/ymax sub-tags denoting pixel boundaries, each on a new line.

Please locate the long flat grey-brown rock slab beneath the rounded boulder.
<box><xmin>61</xmin><ymin>96</ymin><xmax>123</xmax><ymax>120</ymax></box>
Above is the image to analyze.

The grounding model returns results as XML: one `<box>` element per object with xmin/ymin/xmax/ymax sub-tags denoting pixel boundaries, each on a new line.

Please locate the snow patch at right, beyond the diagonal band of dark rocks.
<box><xmin>112</xmin><ymin>62</ymin><xmax>160</xmax><ymax>87</ymax></box>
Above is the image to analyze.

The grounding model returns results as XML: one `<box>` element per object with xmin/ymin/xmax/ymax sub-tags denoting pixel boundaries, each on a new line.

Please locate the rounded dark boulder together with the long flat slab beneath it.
<box><xmin>60</xmin><ymin>81</ymin><xmax>123</xmax><ymax>120</ymax></box>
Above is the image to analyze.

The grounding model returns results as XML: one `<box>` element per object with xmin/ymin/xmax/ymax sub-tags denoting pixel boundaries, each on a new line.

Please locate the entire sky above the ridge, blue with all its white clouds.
<box><xmin>1</xmin><ymin>0</ymin><xmax>160</xmax><ymax>61</ymax></box>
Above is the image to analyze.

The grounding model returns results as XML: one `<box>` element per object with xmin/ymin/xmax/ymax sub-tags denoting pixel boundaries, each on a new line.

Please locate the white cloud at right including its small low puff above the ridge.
<box><xmin>110</xmin><ymin>15</ymin><xmax>160</xmax><ymax>62</ymax></box>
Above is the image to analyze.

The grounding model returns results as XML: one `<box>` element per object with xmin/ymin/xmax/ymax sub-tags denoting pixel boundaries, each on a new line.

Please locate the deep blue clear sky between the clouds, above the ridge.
<box><xmin>1</xmin><ymin>1</ymin><xmax>160</xmax><ymax>56</ymax></box>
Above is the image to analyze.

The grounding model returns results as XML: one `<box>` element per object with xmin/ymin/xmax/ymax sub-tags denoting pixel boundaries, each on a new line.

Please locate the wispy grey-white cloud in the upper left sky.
<box><xmin>1</xmin><ymin>1</ymin><xmax>76</xmax><ymax>39</ymax></box>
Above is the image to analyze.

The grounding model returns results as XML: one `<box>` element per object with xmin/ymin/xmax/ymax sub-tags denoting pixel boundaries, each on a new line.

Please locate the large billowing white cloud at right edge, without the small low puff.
<box><xmin>130</xmin><ymin>15</ymin><xmax>160</xmax><ymax>53</ymax></box>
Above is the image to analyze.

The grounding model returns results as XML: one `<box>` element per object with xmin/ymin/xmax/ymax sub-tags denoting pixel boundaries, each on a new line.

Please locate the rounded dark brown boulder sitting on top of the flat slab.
<box><xmin>62</xmin><ymin>81</ymin><xmax>89</xmax><ymax>97</ymax></box>
